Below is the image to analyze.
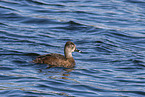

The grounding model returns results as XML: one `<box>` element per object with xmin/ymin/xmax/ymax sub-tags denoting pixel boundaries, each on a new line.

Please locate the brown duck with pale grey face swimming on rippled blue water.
<box><xmin>33</xmin><ymin>41</ymin><xmax>81</xmax><ymax>68</ymax></box>
